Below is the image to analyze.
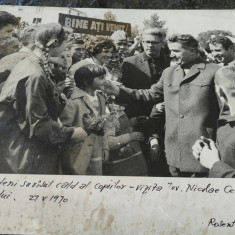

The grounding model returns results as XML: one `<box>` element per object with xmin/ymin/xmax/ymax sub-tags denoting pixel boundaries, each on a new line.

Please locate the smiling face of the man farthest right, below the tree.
<box><xmin>209</xmin><ymin>43</ymin><xmax>233</xmax><ymax>63</ymax></box>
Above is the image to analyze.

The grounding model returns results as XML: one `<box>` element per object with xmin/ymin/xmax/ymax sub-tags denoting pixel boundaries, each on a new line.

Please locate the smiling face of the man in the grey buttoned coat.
<box><xmin>168</xmin><ymin>42</ymin><xmax>194</xmax><ymax>65</ymax></box>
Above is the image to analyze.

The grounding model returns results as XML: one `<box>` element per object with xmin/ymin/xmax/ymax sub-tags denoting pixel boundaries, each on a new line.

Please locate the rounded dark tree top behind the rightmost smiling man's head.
<box><xmin>197</xmin><ymin>30</ymin><xmax>234</xmax><ymax>49</ymax></box>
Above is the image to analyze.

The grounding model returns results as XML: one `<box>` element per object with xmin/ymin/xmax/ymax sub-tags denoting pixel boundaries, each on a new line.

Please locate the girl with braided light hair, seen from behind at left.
<box><xmin>0</xmin><ymin>23</ymin><xmax>87</xmax><ymax>174</ymax></box>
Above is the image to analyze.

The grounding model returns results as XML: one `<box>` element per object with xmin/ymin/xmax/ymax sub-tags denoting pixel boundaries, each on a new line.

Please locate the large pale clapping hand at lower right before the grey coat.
<box><xmin>199</xmin><ymin>140</ymin><xmax>220</xmax><ymax>169</ymax></box>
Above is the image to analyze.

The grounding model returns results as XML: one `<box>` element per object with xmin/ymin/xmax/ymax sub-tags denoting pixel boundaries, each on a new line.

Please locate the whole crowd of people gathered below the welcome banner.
<box><xmin>0</xmin><ymin>11</ymin><xmax>235</xmax><ymax>177</ymax></box>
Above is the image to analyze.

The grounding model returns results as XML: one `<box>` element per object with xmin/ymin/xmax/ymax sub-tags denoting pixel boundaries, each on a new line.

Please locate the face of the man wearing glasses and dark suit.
<box><xmin>142</xmin><ymin>35</ymin><xmax>162</xmax><ymax>58</ymax></box>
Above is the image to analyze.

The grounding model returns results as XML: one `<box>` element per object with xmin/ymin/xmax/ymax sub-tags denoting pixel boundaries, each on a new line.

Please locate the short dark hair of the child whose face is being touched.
<box><xmin>74</xmin><ymin>64</ymin><xmax>106</xmax><ymax>89</ymax></box>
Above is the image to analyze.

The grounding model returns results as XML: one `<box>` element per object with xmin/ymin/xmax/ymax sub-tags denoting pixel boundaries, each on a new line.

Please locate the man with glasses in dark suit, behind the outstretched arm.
<box><xmin>121</xmin><ymin>28</ymin><xmax>170</xmax><ymax>117</ymax></box>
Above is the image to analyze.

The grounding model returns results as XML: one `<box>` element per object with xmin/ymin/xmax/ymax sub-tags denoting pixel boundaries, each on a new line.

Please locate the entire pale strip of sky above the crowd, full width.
<box><xmin>0</xmin><ymin>6</ymin><xmax>235</xmax><ymax>37</ymax></box>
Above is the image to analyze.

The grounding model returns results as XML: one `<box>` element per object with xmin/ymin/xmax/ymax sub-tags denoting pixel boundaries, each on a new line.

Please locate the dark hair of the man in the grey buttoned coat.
<box><xmin>168</xmin><ymin>34</ymin><xmax>199</xmax><ymax>51</ymax></box>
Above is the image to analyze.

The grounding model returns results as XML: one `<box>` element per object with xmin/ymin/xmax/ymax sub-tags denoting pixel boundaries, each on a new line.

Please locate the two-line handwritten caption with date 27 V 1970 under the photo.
<box><xmin>0</xmin><ymin>177</ymin><xmax>235</xmax><ymax>203</ymax></box>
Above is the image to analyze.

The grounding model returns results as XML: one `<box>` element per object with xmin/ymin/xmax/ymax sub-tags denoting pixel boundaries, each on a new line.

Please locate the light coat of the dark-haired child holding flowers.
<box><xmin>60</xmin><ymin>88</ymin><xmax>109</xmax><ymax>175</ymax></box>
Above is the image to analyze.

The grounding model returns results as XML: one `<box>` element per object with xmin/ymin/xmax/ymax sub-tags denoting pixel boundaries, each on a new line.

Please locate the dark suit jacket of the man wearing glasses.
<box><xmin>121</xmin><ymin>52</ymin><xmax>170</xmax><ymax>117</ymax></box>
